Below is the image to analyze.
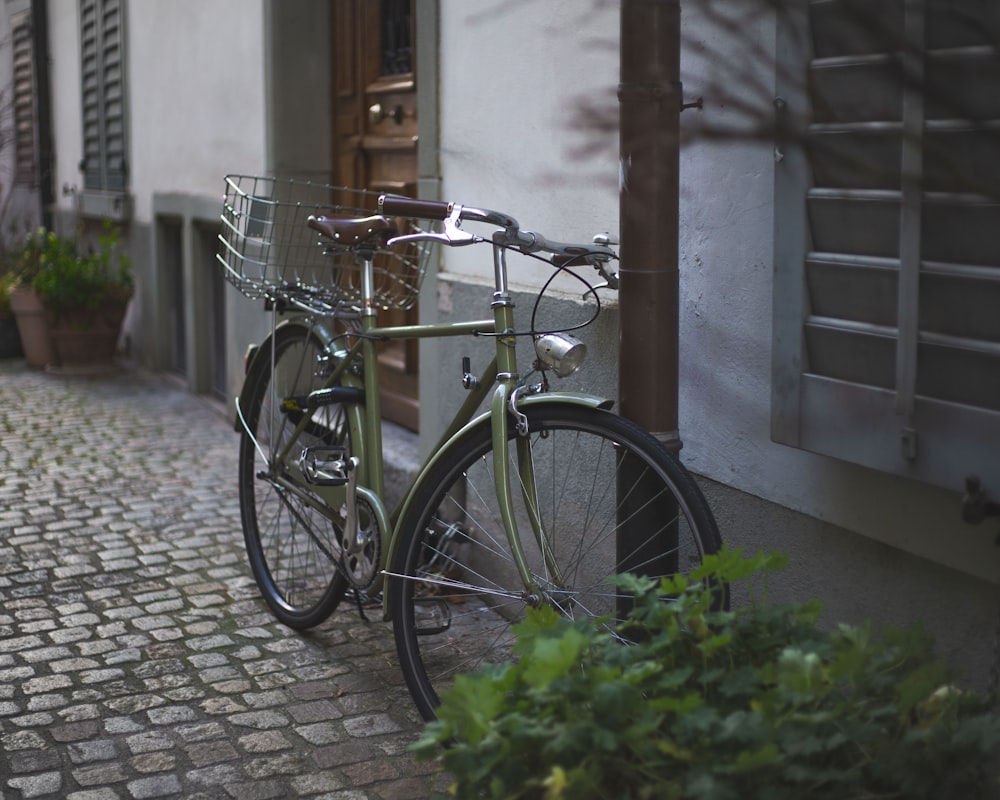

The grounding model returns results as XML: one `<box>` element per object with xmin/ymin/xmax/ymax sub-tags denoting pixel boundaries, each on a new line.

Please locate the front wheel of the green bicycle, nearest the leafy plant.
<box><xmin>390</xmin><ymin>403</ymin><xmax>728</xmax><ymax>720</ymax></box>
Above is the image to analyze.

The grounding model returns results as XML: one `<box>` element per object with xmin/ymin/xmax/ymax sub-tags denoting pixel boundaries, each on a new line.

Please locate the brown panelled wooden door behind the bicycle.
<box><xmin>333</xmin><ymin>0</ymin><xmax>418</xmax><ymax>430</ymax></box>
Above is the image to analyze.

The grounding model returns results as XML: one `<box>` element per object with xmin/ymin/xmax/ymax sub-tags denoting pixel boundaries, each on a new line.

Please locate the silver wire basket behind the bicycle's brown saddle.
<box><xmin>216</xmin><ymin>175</ymin><xmax>431</xmax><ymax>316</ymax></box>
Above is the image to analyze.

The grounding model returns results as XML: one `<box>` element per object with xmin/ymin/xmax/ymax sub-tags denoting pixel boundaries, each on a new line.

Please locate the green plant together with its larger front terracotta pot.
<box><xmin>32</xmin><ymin>225</ymin><xmax>134</xmax><ymax>368</ymax></box>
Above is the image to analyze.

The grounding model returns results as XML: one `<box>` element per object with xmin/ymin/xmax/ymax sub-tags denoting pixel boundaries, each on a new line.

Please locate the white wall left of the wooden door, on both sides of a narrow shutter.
<box><xmin>49</xmin><ymin>0</ymin><xmax>265</xmax><ymax>223</ymax></box>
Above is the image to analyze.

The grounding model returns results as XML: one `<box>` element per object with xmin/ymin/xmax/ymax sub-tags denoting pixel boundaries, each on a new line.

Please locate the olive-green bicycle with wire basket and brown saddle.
<box><xmin>218</xmin><ymin>176</ymin><xmax>726</xmax><ymax>720</ymax></box>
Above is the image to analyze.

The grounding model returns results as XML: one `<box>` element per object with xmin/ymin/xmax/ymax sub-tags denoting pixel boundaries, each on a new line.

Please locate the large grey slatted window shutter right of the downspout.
<box><xmin>772</xmin><ymin>0</ymin><xmax>1000</xmax><ymax>492</ymax></box>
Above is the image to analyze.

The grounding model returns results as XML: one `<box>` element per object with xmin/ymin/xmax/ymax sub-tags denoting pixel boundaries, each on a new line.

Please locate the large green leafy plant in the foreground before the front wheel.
<box><xmin>413</xmin><ymin>551</ymin><xmax>1000</xmax><ymax>800</ymax></box>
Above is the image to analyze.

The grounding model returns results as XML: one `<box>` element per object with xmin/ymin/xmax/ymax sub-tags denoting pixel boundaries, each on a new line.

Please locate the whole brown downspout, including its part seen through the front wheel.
<box><xmin>615</xmin><ymin>0</ymin><xmax>681</xmax><ymax>588</ymax></box>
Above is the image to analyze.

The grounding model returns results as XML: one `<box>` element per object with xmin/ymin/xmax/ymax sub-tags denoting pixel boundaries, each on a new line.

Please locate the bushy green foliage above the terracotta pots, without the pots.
<box><xmin>31</xmin><ymin>225</ymin><xmax>134</xmax><ymax>316</ymax></box>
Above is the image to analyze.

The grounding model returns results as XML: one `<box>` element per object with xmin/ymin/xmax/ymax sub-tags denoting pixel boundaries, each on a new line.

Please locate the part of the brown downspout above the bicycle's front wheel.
<box><xmin>618</xmin><ymin>0</ymin><xmax>682</xmax><ymax>451</ymax></box>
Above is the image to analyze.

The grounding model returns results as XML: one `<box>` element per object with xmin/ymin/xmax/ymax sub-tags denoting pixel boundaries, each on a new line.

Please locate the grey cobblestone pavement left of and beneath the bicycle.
<box><xmin>0</xmin><ymin>361</ymin><xmax>441</xmax><ymax>800</ymax></box>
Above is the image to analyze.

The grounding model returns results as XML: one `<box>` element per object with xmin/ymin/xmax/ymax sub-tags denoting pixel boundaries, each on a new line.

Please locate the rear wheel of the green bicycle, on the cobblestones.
<box><xmin>239</xmin><ymin>325</ymin><xmax>350</xmax><ymax>630</ymax></box>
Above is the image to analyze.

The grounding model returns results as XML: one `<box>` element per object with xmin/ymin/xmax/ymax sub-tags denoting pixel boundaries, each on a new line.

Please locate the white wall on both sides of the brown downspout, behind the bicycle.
<box><xmin>441</xmin><ymin>0</ymin><xmax>1000</xmax><ymax>582</ymax></box>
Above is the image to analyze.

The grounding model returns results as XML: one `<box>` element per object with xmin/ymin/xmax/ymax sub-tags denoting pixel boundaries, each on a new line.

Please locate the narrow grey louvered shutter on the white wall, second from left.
<box><xmin>80</xmin><ymin>0</ymin><xmax>128</xmax><ymax>193</ymax></box>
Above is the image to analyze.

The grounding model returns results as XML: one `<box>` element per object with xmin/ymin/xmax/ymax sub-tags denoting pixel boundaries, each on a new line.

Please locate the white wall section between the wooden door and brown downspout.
<box><xmin>440</xmin><ymin>0</ymin><xmax>618</xmax><ymax>285</ymax></box>
